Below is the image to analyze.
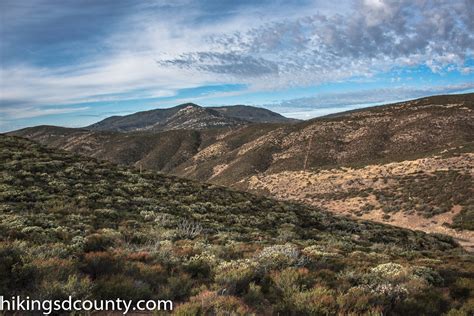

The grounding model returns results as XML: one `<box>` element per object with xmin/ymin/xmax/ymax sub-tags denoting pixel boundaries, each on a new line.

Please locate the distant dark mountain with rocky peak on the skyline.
<box><xmin>86</xmin><ymin>103</ymin><xmax>295</xmax><ymax>132</ymax></box>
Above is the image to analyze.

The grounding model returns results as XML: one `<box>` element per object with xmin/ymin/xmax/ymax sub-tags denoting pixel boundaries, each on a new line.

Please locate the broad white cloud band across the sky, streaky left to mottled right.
<box><xmin>0</xmin><ymin>0</ymin><xmax>474</xmax><ymax>122</ymax></box>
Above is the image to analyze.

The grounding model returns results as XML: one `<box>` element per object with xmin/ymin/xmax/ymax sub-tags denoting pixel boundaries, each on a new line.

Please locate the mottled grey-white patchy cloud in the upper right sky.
<box><xmin>162</xmin><ymin>0</ymin><xmax>474</xmax><ymax>88</ymax></box>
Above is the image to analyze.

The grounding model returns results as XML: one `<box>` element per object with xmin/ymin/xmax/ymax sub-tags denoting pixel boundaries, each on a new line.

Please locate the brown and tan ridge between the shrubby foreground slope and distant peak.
<box><xmin>14</xmin><ymin>94</ymin><xmax>474</xmax><ymax>249</ymax></box>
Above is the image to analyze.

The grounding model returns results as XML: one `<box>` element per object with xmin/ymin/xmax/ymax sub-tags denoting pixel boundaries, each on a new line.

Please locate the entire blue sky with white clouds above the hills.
<box><xmin>0</xmin><ymin>0</ymin><xmax>474</xmax><ymax>132</ymax></box>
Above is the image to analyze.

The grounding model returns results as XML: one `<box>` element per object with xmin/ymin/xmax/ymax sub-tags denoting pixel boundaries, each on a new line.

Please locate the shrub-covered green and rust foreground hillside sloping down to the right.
<box><xmin>0</xmin><ymin>135</ymin><xmax>474</xmax><ymax>315</ymax></box>
